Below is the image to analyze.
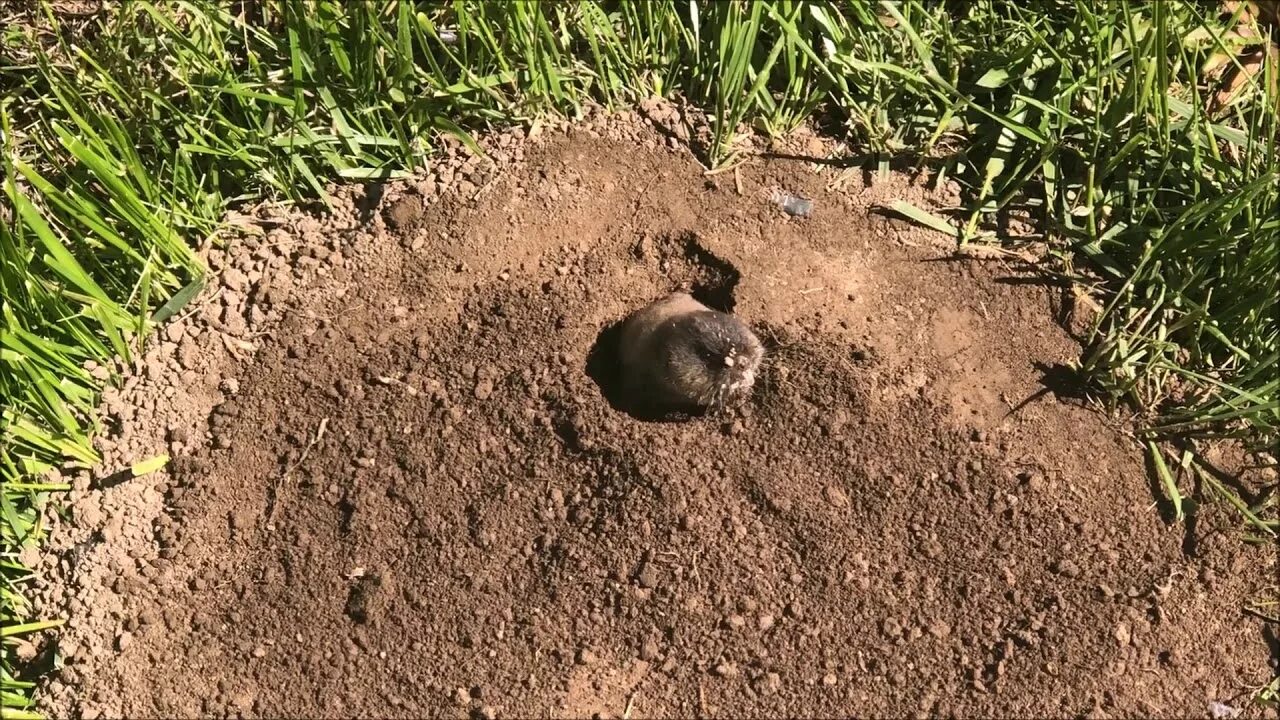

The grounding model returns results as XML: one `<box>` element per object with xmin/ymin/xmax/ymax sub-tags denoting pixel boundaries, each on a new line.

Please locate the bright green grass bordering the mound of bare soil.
<box><xmin>0</xmin><ymin>0</ymin><xmax>1280</xmax><ymax>717</ymax></box>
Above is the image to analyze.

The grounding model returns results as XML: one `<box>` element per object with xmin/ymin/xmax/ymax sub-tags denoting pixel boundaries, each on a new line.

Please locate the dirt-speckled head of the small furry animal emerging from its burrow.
<box><xmin>671</xmin><ymin>310</ymin><xmax>764</xmax><ymax>410</ymax></box>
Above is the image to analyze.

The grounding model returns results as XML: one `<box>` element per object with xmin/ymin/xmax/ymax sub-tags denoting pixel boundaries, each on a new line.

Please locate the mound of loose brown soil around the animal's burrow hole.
<box><xmin>35</xmin><ymin>106</ymin><xmax>1276</xmax><ymax>717</ymax></box>
